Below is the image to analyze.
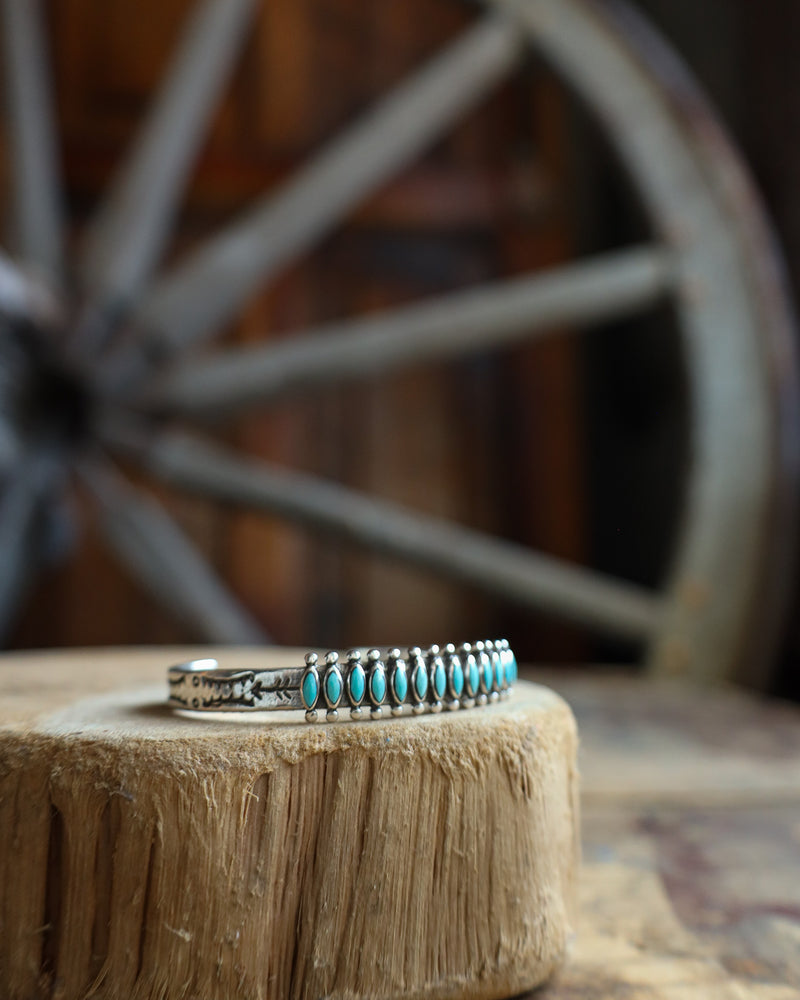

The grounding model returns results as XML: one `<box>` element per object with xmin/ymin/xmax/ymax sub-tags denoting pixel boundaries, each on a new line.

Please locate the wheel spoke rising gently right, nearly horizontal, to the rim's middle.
<box><xmin>149</xmin><ymin>247</ymin><xmax>673</xmax><ymax>417</ymax></box>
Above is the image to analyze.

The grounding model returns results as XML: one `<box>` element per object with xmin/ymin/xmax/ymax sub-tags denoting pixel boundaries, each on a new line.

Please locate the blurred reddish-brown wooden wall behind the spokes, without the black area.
<box><xmin>9</xmin><ymin>0</ymin><xmax>585</xmax><ymax>658</ymax></box>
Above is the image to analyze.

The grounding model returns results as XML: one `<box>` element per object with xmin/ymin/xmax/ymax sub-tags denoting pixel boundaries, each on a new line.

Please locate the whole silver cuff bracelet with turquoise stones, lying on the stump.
<box><xmin>167</xmin><ymin>639</ymin><xmax>517</xmax><ymax>722</ymax></box>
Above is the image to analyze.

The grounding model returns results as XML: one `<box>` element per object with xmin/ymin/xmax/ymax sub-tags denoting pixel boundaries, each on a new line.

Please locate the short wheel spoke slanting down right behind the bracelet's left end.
<box><xmin>79</xmin><ymin>461</ymin><xmax>267</xmax><ymax>644</ymax></box>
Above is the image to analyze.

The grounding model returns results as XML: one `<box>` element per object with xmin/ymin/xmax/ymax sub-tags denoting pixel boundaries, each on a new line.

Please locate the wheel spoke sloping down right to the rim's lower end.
<box><xmin>111</xmin><ymin>433</ymin><xmax>661</xmax><ymax>639</ymax></box>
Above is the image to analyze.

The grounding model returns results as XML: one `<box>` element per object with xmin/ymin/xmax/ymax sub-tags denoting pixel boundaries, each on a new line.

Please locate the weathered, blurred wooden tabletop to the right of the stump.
<box><xmin>527</xmin><ymin>672</ymin><xmax>800</xmax><ymax>1000</ymax></box>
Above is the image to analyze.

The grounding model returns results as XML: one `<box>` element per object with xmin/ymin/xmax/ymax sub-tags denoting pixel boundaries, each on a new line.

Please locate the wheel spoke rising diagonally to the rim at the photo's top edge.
<box><xmin>123</xmin><ymin>18</ymin><xmax>522</xmax><ymax>364</ymax></box>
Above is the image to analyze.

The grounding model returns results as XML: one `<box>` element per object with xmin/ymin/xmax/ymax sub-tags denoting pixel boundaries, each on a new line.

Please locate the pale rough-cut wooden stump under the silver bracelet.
<box><xmin>0</xmin><ymin>649</ymin><xmax>579</xmax><ymax>1000</ymax></box>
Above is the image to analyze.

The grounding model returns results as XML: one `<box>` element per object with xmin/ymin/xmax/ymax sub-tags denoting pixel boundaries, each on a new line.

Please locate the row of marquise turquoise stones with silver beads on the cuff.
<box><xmin>300</xmin><ymin>639</ymin><xmax>517</xmax><ymax>722</ymax></box>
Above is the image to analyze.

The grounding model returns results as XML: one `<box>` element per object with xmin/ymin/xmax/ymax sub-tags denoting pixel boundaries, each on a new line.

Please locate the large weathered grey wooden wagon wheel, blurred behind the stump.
<box><xmin>0</xmin><ymin>0</ymin><xmax>796</xmax><ymax>677</ymax></box>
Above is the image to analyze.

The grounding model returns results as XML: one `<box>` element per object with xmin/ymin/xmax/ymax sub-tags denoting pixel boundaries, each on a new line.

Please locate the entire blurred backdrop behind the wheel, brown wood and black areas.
<box><xmin>1</xmin><ymin>0</ymin><xmax>800</xmax><ymax>695</ymax></box>
